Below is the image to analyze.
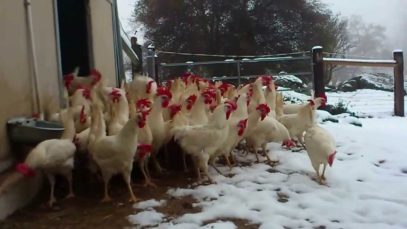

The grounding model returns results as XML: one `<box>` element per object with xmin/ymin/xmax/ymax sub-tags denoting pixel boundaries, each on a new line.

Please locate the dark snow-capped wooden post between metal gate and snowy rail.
<box><xmin>312</xmin><ymin>46</ymin><xmax>325</xmax><ymax>97</ymax></box>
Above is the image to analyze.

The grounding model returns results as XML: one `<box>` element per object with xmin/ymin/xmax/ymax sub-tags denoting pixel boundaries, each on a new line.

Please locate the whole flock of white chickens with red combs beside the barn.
<box><xmin>0</xmin><ymin>70</ymin><xmax>336</xmax><ymax>209</ymax></box>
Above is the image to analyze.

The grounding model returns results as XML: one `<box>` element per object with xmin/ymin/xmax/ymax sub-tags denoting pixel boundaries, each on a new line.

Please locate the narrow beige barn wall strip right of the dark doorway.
<box><xmin>89</xmin><ymin>0</ymin><xmax>117</xmax><ymax>86</ymax></box>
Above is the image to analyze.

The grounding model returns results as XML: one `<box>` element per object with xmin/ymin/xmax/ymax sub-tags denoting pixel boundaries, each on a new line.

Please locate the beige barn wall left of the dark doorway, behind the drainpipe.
<box><xmin>0</xmin><ymin>0</ymin><xmax>59</xmax><ymax>172</ymax></box>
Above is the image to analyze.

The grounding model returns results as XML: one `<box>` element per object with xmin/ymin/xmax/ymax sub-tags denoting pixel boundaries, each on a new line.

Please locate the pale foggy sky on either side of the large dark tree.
<box><xmin>117</xmin><ymin>0</ymin><xmax>407</xmax><ymax>81</ymax></box>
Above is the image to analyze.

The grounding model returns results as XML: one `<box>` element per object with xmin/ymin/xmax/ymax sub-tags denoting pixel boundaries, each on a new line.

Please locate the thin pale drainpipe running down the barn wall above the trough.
<box><xmin>24</xmin><ymin>0</ymin><xmax>44</xmax><ymax>119</ymax></box>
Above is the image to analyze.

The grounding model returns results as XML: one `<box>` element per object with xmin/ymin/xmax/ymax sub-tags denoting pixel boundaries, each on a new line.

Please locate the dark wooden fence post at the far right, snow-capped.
<box><xmin>393</xmin><ymin>50</ymin><xmax>404</xmax><ymax>117</ymax></box>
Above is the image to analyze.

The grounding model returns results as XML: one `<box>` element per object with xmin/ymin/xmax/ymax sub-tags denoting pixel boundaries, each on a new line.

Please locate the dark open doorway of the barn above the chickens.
<box><xmin>57</xmin><ymin>0</ymin><xmax>91</xmax><ymax>75</ymax></box>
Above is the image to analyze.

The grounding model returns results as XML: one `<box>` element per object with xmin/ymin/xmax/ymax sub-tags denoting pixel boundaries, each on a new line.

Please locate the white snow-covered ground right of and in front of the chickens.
<box><xmin>129</xmin><ymin>90</ymin><xmax>407</xmax><ymax>229</ymax></box>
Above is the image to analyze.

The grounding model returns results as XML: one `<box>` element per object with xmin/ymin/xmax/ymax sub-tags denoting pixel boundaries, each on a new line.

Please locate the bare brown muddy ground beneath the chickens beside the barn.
<box><xmin>0</xmin><ymin>161</ymin><xmax>200</xmax><ymax>229</ymax></box>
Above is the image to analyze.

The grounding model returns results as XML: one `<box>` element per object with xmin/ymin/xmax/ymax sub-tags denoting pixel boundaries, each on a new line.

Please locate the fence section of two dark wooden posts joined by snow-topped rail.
<box><xmin>312</xmin><ymin>46</ymin><xmax>404</xmax><ymax>117</ymax></box>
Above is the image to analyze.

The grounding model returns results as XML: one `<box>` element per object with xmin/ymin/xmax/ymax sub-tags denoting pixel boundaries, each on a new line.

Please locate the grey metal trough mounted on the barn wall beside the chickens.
<box><xmin>7</xmin><ymin>117</ymin><xmax>64</xmax><ymax>144</ymax></box>
